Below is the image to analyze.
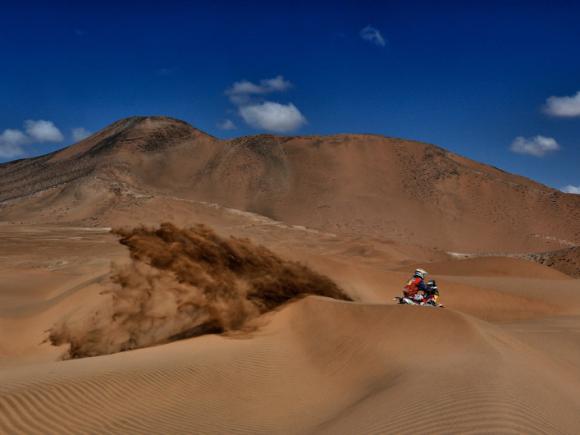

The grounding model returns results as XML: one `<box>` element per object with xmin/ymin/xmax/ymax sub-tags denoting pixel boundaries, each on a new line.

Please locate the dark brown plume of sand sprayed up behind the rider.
<box><xmin>49</xmin><ymin>223</ymin><xmax>350</xmax><ymax>358</ymax></box>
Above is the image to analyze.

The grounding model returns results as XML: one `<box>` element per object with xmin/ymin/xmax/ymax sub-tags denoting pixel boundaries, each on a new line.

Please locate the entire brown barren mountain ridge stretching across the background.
<box><xmin>0</xmin><ymin>117</ymin><xmax>580</xmax><ymax>253</ymax></box>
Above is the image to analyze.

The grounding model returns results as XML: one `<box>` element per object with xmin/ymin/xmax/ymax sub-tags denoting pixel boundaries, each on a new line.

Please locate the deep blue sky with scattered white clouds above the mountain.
<box><xmin>0</xmin><ymin>0</ymin><xmax>580</xmax><ymax>188</ymax></box>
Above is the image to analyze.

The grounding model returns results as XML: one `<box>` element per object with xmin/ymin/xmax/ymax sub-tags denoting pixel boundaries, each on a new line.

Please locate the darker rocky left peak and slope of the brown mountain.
<box><xmin>0</xmin><ymin>117</ymin><xmax>212</xmax><ymax>202</ymax></box>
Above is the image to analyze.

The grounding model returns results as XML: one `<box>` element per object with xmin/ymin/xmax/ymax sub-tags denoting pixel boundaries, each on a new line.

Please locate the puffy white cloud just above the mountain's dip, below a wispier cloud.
<box><xmin>239</xmin><ymin>101</ymin><xmax>306</xmax><ymax>133</ymax></box>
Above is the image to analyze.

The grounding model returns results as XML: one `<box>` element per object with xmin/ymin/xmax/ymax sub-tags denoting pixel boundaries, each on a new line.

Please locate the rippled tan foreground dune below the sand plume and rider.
<box><xmin>0</xmin><ymin>297</ymin><xmax>580</xmax><ymax>434</ymax></box>
